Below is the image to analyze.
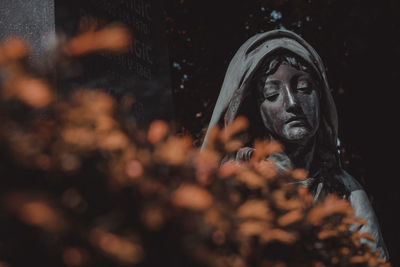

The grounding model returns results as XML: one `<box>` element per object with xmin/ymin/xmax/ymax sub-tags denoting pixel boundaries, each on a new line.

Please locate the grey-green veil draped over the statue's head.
<box><xmin>203</xmin><ymin>30</ymin><xmax>338</xmax><ymax>152</ymax></box>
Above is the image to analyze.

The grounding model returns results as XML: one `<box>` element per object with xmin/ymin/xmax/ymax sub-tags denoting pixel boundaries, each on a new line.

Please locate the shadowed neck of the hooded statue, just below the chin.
<box><xmin>284</xmin><ymin>138</ymin><xmax>316</xmax><ymax>175</ymax></box>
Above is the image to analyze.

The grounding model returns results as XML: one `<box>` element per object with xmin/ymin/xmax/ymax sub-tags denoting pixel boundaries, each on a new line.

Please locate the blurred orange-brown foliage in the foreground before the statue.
<box><xmin>0</xmin><ymin>21</ymin><xmax>388</xmax><ymax>267</ymax></box>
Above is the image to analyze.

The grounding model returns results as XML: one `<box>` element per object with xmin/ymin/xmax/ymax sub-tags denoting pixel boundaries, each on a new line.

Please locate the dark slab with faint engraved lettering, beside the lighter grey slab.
<box><xmin>55</xmin><ymin>0</ymin><xmax>174</xmax><ymax>123</ymax></box>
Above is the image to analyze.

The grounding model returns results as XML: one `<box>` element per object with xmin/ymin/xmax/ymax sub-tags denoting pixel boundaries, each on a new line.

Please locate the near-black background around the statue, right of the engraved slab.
<box><xmin>166</xmin><ymin>0</ymin><xmax>400</xmax><ymax>266</ymax></box>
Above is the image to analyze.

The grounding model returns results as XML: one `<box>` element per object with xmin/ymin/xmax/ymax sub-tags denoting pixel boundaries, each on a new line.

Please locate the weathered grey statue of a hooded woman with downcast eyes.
<box><xmin>203</xmin><ymin>30</ymin><xmax>389</xmax><ymax>260</ymax></box>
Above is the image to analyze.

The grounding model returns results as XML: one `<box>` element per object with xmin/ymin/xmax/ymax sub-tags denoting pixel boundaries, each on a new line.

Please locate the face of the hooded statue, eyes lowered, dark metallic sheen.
<box><xmin>260</xmin><ymin>63</ymin><xmax>320</xmax><ymax>144</ymax></box>
